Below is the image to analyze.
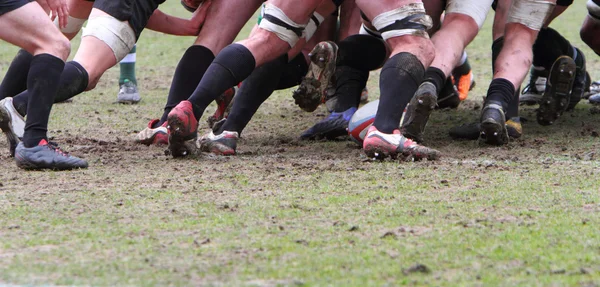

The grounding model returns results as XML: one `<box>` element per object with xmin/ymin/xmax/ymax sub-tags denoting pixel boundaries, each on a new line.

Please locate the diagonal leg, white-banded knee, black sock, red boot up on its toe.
<box><xmin>168</xmin><ymin>0</ymin><xmax>321</xmax><ymax>156</ymax></box>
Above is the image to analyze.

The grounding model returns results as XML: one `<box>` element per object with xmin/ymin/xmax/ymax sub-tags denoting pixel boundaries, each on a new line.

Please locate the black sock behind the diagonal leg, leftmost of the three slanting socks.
<box><xmin>156</xmin><ymin>45</ymin><xmax>215</xmax><ymax>126</ymax></box>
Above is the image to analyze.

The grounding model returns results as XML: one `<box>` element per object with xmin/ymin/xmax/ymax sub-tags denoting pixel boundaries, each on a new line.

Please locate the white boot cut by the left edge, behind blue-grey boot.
<box><xmin>0</xmin><ymin>97</ymin><xmax>25</xmax><ymax>156</ymax></box>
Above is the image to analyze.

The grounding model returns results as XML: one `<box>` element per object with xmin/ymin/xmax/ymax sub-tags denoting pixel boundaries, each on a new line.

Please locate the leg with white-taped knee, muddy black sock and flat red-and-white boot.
<box><xmin>356</xmin><ymin>0</ymin><xmax>439</xmax><ymax>159</ymax></box>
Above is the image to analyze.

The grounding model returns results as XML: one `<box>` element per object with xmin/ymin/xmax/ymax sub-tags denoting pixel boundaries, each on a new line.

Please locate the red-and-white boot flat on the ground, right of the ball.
<box><xmin>363</xmin><ymin>126</ymin><xmax>440</xmax><ymax>160</ymax></box>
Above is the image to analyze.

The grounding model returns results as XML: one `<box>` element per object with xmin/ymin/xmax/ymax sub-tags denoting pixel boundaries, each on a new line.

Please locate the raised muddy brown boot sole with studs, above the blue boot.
<box><xmin>293</xmin><ymin>41</ymin><xmax>338</xmax><ymax>112</ymax></box>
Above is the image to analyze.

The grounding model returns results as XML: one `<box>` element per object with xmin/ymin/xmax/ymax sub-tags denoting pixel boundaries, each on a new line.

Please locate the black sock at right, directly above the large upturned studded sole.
<box><xmin>532</xmin><ymin>27</ymin><xmax>574</xmax><ymax>71</ymax></box>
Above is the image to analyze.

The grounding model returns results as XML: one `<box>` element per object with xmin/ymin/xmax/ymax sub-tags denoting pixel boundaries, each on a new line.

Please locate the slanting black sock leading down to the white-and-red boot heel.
<box><xmin>217</xmin><ymin>54</ymin><xmax>288</xmax><ymax>134</ymax></box>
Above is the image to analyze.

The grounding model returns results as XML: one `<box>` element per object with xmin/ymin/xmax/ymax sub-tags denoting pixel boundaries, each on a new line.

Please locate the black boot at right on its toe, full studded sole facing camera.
<box><xmin>537</xmin><ymin>56</ymin><xmax>577</xmax><ymax>126</ymax></box>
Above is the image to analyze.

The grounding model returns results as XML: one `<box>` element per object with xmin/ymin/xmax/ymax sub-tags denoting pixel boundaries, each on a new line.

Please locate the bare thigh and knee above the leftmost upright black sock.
<box><xmin>0</xmin><ymin>2</ymin><xmax>64</xmax><ymax>55</ymax></box>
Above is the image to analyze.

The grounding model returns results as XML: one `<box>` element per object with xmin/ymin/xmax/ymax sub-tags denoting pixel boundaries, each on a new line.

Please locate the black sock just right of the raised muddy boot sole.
<box><xmin>332</xmin><ymin>66</ymin><xmax>369</xmax><ymax>113</ymax></box>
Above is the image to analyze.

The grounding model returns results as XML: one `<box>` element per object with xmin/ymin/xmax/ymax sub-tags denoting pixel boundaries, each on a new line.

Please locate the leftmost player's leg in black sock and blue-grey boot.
<box><xmin>0</xmin><ymin>1</ymin><xmax>87</xmax><ymax>169</ymax></box>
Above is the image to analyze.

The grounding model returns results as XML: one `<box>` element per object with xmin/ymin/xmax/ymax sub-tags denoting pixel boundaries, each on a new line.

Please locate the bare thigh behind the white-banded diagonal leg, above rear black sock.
<box><xmin>194</xmin><ymin>0</ymin><xmax>262</xmax><ymax>55</ymax></box>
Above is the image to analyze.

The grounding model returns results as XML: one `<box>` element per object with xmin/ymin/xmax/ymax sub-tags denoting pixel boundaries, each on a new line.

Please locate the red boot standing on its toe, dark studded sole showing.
<box><xmin>167</xmin><ymin>101</ymin><xmax>198</xmax><ymax>157</ymax></box>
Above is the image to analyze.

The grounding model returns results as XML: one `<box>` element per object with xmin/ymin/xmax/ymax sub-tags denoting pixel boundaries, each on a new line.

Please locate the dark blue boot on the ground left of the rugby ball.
<box><xmin>300</xmin><ymin>107</ymin><xmax>356</xmax><ymax>140</ymax></box>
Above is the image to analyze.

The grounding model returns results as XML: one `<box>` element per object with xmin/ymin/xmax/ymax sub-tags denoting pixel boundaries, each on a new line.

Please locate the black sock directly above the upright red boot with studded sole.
<box><xmin>188</xmin><ymin>44</ymin><xmax>256</xmax><ymax>119</ymax></box>
